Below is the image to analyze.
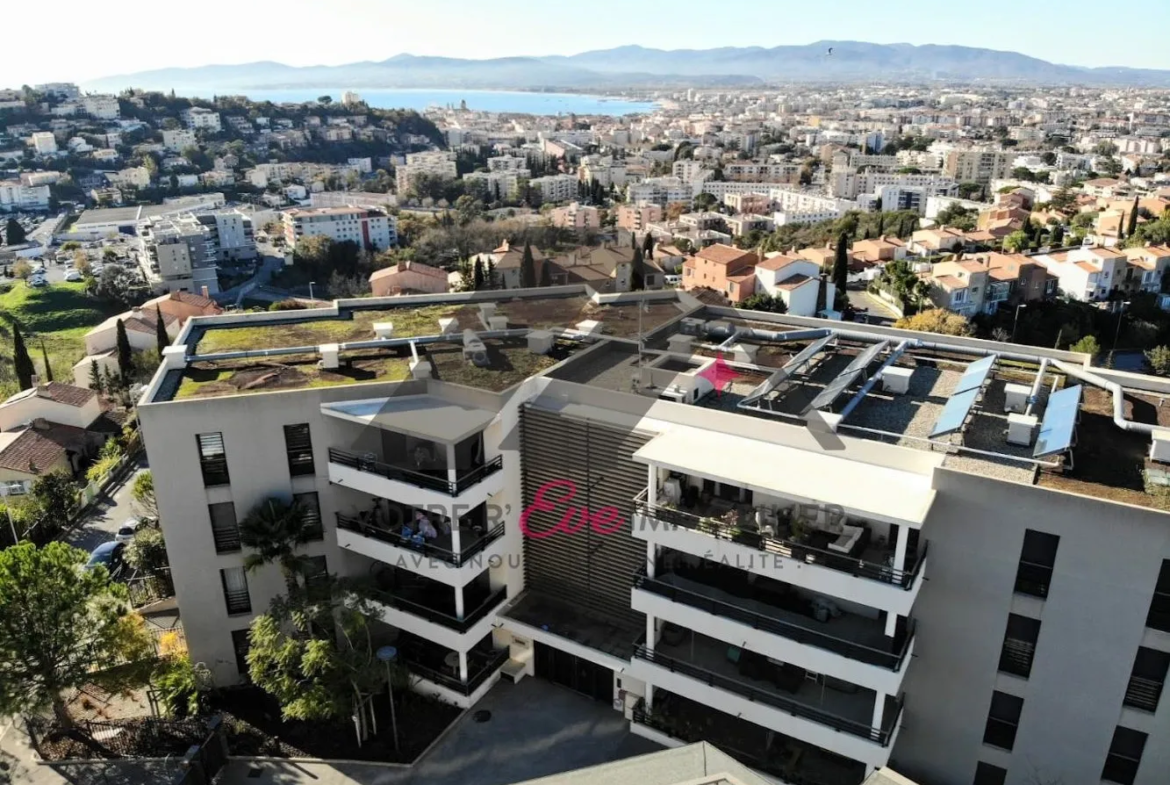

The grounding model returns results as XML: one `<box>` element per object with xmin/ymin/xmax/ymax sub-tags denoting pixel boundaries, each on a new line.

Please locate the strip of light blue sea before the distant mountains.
<box><xmin>204</xmin><ymin>88</ymin><xmax>655</xmax><ymax>116</ymax></box>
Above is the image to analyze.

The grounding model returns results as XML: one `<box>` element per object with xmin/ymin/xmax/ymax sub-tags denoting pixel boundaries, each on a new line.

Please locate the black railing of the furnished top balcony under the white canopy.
<box><xmin>634</xmin><ymin>491</ymin><xmax>927</xmax><ymax>590</ymax></box>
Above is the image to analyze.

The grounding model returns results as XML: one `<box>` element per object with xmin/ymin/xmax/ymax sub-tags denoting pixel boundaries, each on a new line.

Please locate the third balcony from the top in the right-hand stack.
<box><xmin>631</xmin><ymin>635</ymin><xmax>902</xmax><ymax>766</ymax></box>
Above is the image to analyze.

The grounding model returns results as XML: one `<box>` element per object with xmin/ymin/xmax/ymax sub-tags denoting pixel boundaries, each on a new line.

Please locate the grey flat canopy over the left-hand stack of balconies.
<box><xmin>321</xmin><ymin>395</ymin><xmax>496</xmax><ymax>445</ymax></box>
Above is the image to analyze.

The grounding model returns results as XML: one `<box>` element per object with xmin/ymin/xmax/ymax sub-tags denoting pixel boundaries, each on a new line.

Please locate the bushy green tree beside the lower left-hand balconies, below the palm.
<box><xmin>248</xmin><ymin>577</ymin><xmax>385</xmax><ymax>721</ymax></box>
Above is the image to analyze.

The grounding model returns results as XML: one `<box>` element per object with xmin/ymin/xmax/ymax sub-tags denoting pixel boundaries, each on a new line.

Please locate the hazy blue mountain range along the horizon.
<box><xmin>85</xmin><ymin>41</ymin><xmax>1170</xmax><ymax>92</ymax></box>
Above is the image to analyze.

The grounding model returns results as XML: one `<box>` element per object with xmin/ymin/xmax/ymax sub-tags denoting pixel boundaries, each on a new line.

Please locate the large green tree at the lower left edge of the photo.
<box><xmin>0</xmin><ymin>542</ymin><xmax>152</xmax><ymax>729</ymax></box>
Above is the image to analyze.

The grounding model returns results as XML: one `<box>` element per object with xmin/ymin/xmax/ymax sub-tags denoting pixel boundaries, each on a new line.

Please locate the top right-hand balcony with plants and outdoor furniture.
<box><xmin>634</xmin><ymin>500</ymin><xmax>927</xmax><ymax>615</ymax></box>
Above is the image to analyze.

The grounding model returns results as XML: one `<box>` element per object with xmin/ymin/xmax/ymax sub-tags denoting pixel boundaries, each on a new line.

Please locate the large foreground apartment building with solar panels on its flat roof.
<box><xmin>138</xmin><ymin>290</ymin><xmax>1170</xmax><ymax>785</ymax></box>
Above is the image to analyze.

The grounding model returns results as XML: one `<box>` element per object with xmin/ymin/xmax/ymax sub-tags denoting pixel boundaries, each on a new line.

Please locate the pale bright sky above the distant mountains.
<box><xmin>9</xmin><ymin>0</ymin><xmax>1170</xmax><ymax>85</ymax></box>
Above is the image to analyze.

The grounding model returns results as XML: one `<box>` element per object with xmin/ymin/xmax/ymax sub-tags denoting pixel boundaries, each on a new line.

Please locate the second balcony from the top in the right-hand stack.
<box><xmin>632</xmin><ymin>565</ymin><xmax>915</xmax><ymax>694</ymax></box>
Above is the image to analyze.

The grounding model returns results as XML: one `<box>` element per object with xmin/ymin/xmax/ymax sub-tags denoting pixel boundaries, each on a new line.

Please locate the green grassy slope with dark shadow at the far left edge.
<box><xmin>0</xmin><ymin>281</ymin><xmax>118</xmax><ymax>398</ymax></box>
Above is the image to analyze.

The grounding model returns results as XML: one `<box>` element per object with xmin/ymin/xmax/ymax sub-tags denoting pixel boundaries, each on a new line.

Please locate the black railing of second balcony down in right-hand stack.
<box><xmin>634</xmin><ymin>566</ymin><xmax>914</xmax><ymax>670</ymax></box>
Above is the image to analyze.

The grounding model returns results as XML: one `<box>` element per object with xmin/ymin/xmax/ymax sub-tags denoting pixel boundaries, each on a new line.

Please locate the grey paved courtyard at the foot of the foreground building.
<box><xmin>221</xmin><ymin>679</ymin><xmax>661</xmax><ymax>785</ymax></box>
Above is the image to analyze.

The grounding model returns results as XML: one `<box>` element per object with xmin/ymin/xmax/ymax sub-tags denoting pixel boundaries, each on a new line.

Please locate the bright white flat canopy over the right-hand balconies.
<box><xmin>634</xmin><ymin>426</ymin><xmax>935</xmax><ymax>528</ymax></box>
